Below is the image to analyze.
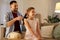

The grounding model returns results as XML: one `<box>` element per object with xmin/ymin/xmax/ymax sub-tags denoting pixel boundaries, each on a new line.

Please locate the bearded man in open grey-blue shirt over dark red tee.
<box><xmin>5</xmin><ymin>1</ymin><xmax>22</xmax><ymax>37</ymax></box>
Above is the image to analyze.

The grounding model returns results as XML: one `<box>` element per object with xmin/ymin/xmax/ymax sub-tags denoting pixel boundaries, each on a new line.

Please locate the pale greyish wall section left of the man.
<box><xmin>0</xmin><ymin>0</ymin><xmax>10</xmax><ymax>24</ymax></box>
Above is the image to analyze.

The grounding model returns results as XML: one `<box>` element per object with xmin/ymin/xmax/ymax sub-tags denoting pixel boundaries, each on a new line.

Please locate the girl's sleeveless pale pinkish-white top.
<box><xmin>25</xmin><ymin>18</ymin><xmax>38</xmax><ymax>40</ymax></box>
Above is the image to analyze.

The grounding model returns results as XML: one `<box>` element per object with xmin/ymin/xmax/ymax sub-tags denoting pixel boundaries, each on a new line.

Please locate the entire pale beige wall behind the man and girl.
<box><xmin>0</xmin><ymin>0</ymin><xmax>60</xmax><ymax>23</ymax></box>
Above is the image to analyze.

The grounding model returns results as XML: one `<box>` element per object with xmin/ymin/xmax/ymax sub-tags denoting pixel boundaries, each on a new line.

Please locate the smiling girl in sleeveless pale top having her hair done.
<box><xmin>24</xmin><ymin>7</ymin><xmax>41</xmax><ymax>40</ymax></box>
